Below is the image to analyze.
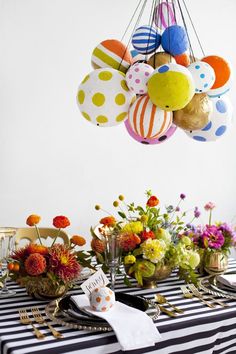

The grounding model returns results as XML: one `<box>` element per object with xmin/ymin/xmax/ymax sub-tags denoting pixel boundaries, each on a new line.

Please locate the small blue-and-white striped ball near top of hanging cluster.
<box><xmin>132</xmin><ymin>26</ymin><xmax>161</xmax><ymax>54</ymax></box>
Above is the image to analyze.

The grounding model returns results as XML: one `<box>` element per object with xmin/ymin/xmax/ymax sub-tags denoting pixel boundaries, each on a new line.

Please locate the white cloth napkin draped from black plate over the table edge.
<box><xmin>71</xmin><ymin>295</ymin><xmax>161</xmax><ymax>350</ymax></box>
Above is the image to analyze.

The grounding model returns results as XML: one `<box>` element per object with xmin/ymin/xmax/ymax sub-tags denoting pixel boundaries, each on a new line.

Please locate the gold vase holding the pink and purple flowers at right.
<box><xmin>204</xmin><ymin>251</ymin><xmax>228</xmax><ymax>275</ymax></box>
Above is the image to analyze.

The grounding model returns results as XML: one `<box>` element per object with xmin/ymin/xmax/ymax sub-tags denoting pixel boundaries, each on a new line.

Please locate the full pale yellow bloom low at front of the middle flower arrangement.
<box><xmin>141</xmin><ymin>238</ymin><xmax>166</xmax><ymax>263</ymax></box>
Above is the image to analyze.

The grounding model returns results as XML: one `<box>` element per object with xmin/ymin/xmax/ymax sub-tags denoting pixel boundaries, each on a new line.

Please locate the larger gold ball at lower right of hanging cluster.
<box><xmin>173</xmin><ymin>93</ymin><xmax>213</xmax><ymax>130</ymax></box>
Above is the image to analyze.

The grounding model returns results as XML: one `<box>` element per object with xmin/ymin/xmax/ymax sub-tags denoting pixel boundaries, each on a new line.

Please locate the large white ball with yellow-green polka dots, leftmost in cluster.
<box><xmin>77</xmin><ymin>68</ymin><xmax>136</xmax><ymax>127</ymax></box>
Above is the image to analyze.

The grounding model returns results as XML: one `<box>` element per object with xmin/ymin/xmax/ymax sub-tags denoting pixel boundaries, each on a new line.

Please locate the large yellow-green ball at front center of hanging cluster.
<box><xmin>148</xmin><ymin>63</ymin><xmax>195</xmax><ymax>111</ymax></box>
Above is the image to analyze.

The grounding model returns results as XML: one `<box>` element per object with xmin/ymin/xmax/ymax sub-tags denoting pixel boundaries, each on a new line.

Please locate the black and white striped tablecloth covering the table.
<box><xmin>0</xmin><ymin>260</ymin><xmax>236</xmax><ymax>354</ymax></box>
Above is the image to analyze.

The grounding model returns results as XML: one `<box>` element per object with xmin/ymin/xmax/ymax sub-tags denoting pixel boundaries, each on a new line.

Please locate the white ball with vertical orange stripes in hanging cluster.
<box><xmin>129</xmin><ymin>95</ymin><xmax>173</xmax><ymax>139</ymax></box>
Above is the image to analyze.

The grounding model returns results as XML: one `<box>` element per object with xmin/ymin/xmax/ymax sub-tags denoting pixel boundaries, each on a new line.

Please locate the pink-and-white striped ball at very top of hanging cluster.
<box><xmin>154</xmin><ymin>2</ymin><xmax>176</xmax><ymax>29</ymax></box>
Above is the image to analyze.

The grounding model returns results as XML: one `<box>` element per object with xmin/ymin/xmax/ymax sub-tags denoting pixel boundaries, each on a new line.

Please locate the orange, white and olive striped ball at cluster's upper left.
<box><xmin>92</xmin><ymin>39</ymin><xmax>133</xmax><ymax>73</ymax></box>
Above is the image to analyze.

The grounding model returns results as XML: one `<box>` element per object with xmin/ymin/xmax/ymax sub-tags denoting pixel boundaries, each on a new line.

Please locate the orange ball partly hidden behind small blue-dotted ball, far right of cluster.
<box><xmin>202</xmin><ymin>55</ymin><xmax>231</xmax><ymax>90</ymax></box>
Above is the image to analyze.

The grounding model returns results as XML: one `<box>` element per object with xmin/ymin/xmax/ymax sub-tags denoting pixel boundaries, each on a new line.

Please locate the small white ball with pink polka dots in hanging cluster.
<box><xmin>125</xmin><ymin>63</ymin><xmax>154</xmax><ymax>95</ymax></box>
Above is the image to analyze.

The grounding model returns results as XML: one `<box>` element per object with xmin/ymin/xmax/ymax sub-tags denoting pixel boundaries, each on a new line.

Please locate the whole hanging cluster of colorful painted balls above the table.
<box><xmin>77</xmin><ymin>4</ymin><xmax>232</xmax><ymax>144</ymax></box>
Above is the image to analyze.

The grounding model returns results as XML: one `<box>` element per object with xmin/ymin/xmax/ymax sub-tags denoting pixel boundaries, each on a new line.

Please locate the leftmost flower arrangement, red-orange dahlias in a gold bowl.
<box><xmin>8</xmin><ymin>215</ymin><xmax>86</xmax><ymax>298</ymax></box>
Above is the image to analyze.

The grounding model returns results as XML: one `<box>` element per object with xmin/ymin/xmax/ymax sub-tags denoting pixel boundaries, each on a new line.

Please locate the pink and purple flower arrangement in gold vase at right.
<box><xmin>185</xmin><ymin>202</ymin><xmax>236</xmax><ymax>274</ymax></box>
